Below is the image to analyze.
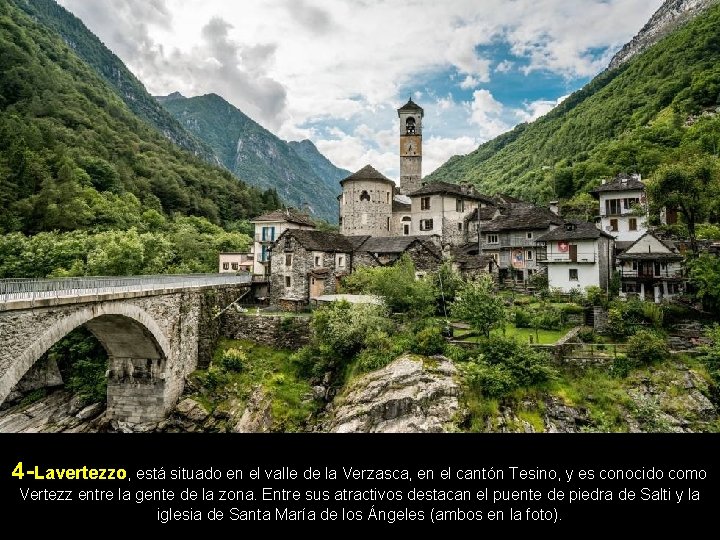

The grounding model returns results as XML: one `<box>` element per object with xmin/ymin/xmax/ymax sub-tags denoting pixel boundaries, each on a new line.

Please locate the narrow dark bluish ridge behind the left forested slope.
<box><xmin>13</xmin><ymin>0</ymin><xmax>218</xmax><ymax>164</ymax></box>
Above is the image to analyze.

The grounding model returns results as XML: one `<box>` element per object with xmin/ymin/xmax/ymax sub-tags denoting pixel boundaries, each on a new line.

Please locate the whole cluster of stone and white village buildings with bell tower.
<box><xmin>219</xmin><ymin>99</ymin><xmax>685</xmax><ymax>310</ymax></box>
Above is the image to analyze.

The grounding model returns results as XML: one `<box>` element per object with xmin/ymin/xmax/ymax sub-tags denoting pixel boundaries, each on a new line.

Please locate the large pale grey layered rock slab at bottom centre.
<box><xmin>326</xmin><ymin>355</ymin><xmax>460</xmax><ymax>433</ymax></box>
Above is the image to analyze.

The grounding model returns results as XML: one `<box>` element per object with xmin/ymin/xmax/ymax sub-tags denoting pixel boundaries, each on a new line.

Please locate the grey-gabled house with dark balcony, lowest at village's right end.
<box><xmin>617</xmin><ymin>232</ymin><xmax>686</xmax><ymax>303</ymax></box>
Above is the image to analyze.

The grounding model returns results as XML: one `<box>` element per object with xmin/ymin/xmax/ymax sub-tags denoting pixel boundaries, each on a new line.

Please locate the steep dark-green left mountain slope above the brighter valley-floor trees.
<box><xmin>0</xmin><ymin>2</ymin><xmax>278</xmax><ymax>235</ymax></box>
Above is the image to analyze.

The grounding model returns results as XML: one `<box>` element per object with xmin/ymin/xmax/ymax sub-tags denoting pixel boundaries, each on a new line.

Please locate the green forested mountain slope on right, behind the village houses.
<box><xmin>426</xmin><ymin>0</ymin><xmax>720</xmax><ymax>202</ymax></box>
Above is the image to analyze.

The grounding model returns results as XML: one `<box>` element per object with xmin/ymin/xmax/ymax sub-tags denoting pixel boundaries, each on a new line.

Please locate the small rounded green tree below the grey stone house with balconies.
<box><xmin>450</xmin><ymin>276</ymin><xmax>505</xmax><ymax>337</ymax></box>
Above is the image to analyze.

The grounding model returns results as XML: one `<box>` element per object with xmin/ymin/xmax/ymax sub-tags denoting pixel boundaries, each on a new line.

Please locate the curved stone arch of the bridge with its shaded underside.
<box><xmin>0</xmin><ymin>302</ymin><xmax>171</xmax><ymax>417</ymax></box>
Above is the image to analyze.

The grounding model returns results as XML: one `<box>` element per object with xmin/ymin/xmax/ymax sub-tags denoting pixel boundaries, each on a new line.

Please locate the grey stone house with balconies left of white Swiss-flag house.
<box><xmin>479</xmin><ymin>199</ymin><xmax>564</xmax><ymax>283</ymax></box>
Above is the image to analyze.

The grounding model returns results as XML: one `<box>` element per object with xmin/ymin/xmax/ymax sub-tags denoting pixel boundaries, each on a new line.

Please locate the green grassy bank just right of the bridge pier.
<box><xmin>193</xmin><ymin>339</ymin><xmax>318</xmax><ymax>432</ymax></box>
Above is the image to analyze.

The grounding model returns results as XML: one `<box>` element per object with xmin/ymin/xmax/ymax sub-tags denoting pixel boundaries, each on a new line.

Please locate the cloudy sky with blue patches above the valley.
<box><xmin>58</xmin><ymin>0</ymin><xmax>662</xmax><ymax>180</ymax></box>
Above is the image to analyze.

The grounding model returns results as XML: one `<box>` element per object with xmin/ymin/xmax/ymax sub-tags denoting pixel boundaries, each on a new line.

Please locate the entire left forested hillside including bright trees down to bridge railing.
<box><xmin>0</xmin><ymin>2</ymin><xmax>280</xmax><ymax>277</ymax></box>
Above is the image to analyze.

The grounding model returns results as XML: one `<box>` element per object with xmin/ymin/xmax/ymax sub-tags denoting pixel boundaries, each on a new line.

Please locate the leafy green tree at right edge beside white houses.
<box><xmin>648</xmin><ymin>155</ymin><xmax>720</xmax><ymax>256</ymax></box>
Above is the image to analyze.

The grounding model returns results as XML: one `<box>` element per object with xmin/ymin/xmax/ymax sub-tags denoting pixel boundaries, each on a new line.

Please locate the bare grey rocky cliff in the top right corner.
<box><xmin>608</xmin><ymin>0</ymin><xmax>718</xmax><ymax>69</ymax></box>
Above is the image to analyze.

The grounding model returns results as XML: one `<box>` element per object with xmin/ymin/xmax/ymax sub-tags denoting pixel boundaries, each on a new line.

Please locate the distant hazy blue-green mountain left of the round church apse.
<box><xmin>162</xmin><ymin>92</ymin><xmax>350</xmax><ymax>223</ymax></box>
